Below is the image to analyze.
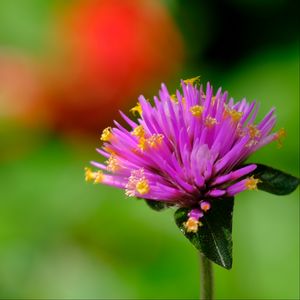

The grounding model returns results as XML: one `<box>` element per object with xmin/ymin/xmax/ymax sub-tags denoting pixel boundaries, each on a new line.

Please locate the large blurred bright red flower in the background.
<box><xmin>42</xmin><ymin>0</ymin><xmax>183</xmax><ymax>132</ymax></box>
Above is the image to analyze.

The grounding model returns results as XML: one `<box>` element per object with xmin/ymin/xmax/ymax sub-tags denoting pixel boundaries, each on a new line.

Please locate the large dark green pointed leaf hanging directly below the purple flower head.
<box><xmin>175</xmin><ymin>198</ymin><xmax>234</xmax><ymax>269</ymax></box>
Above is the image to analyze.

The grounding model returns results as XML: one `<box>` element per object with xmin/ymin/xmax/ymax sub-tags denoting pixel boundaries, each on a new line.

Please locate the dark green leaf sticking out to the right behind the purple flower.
<box><xmin>251</xmin><ymin>164</ymin><xmax>300</xmax><ymax>195</ymax></box>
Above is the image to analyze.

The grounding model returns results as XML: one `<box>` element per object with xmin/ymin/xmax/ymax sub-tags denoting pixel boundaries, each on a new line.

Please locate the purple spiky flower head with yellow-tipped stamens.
<box><xmin>86</xmin><ymin>77</ymin><xmax>284</xmax><ymax>232</ymax></box>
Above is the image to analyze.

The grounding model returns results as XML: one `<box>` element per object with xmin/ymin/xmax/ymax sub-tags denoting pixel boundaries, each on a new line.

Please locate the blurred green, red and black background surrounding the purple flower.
<box><xmin>0</xmin><ymin>0</ymin><xmax>299</xmax><ymax>299</ymax></box>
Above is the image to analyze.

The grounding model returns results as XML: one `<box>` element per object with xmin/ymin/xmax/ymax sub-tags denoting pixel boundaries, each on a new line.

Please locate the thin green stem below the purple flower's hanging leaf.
<box><xmin>200</xmin><ymin>253</ymin><xmax>214</xmax><ymax>300</ymax></box>
